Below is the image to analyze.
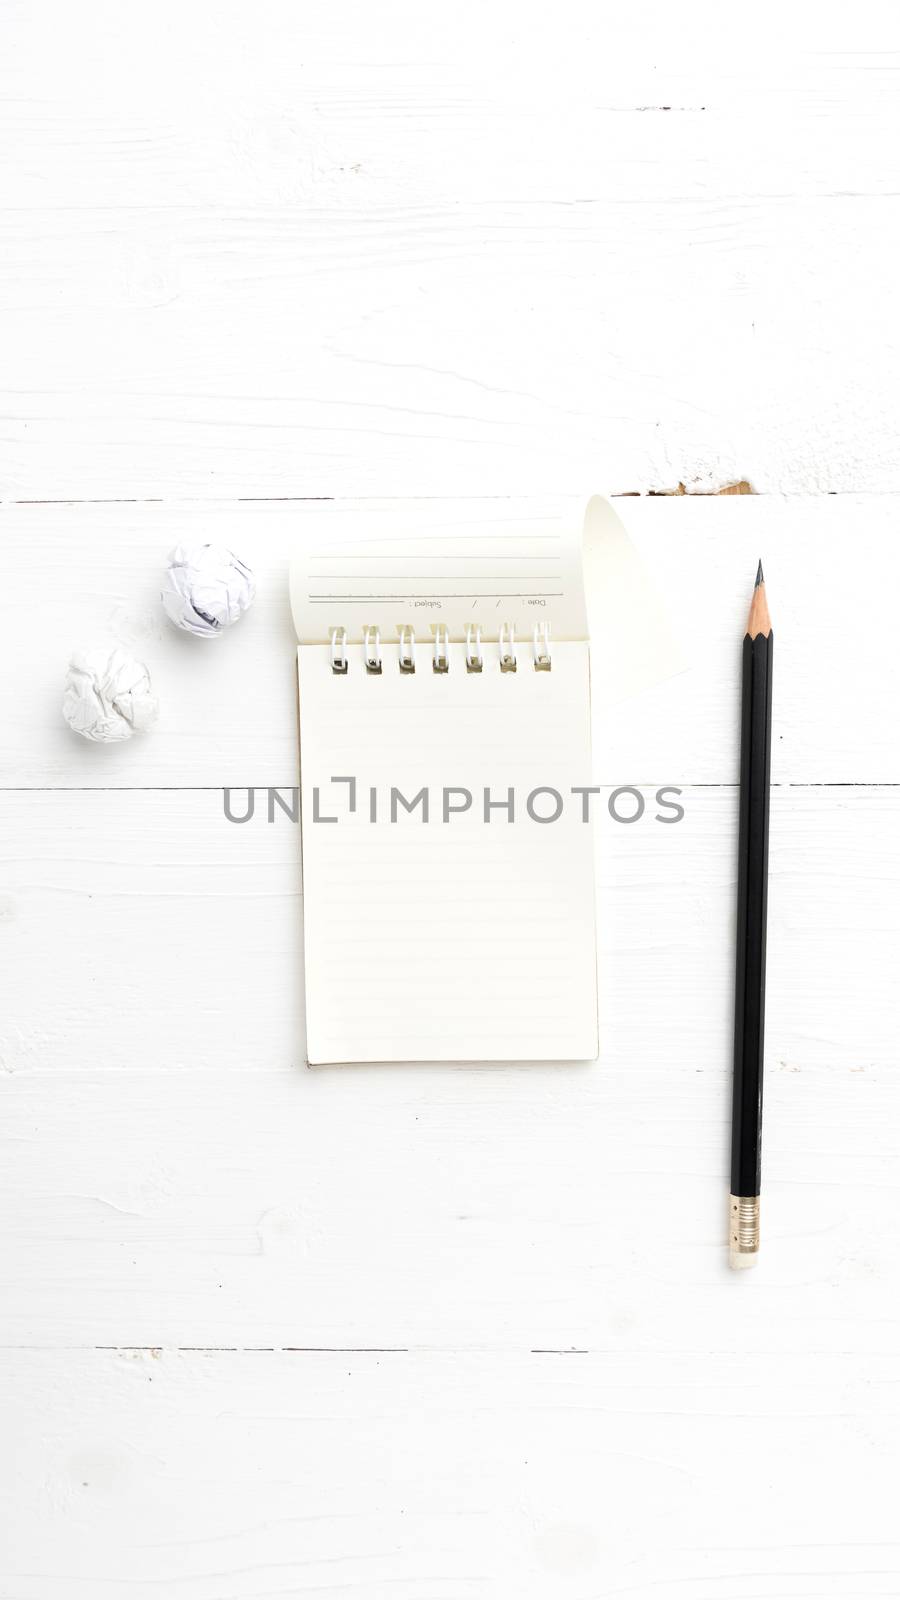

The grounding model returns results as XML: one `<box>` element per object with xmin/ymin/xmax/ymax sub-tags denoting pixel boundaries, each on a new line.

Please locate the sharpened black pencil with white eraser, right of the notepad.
<box><xmin>729</xmin><ymin>562</ymin><xmax>772</xmax><ymax>1267</ymax></box>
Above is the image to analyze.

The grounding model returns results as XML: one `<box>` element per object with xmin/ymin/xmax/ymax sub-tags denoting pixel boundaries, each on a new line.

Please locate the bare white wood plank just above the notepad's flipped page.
<box><xmin>0</xmin><ymin>192</ymin><xmax>900</xmax><ymax>499</ymax></box>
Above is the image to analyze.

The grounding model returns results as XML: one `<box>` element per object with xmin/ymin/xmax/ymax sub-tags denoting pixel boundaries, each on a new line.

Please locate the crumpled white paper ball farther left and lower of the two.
<box><xmin>62</xmin><ymin>646</ymin><xmax>159</xmax><ymax>744</ymax></box>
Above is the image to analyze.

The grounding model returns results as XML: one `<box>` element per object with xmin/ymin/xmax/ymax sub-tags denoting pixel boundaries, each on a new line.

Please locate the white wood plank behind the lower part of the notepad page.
<box><xmin>0</xmin><ymin>786</ymin><xmax>900</xmax><ymax>1082</ymax></box>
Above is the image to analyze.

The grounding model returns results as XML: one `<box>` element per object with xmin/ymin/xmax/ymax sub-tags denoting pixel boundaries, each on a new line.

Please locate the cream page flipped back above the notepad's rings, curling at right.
<box><xmin>290</xmin><ymin>494</ymin><xmax>682</xmax><ymax>706</ymax></box>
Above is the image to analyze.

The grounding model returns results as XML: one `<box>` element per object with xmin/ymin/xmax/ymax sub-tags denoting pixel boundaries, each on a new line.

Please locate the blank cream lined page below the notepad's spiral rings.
<box><xmin>298</xmin><ymin>643</ymin><xmax>597</xmax><ymax>1064</ymax></box>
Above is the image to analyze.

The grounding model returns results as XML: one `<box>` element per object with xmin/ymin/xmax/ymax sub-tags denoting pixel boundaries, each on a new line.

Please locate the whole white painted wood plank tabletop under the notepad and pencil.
<box><xmin>0</xmin><ymin>0</ymin><xmax>900</xmax><ymax>1600</ymax></box>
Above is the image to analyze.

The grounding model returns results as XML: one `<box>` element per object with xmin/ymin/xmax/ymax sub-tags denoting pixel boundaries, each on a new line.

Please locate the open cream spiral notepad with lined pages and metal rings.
<box><xmin>291</xmin><ymin>492</ymin><xmax>637</xmax><ymax>1064</ymax></box>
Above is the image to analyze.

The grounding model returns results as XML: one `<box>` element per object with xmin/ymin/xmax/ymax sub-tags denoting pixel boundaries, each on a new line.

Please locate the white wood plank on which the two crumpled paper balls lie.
<box><xmin>0</xmin><ymin>496</ymin><xmax>900</xmax><ymax>787</ymax></box>
